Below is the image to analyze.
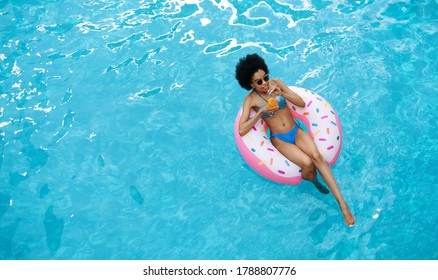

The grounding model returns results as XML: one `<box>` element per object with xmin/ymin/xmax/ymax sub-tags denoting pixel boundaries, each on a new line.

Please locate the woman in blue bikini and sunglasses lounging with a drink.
<box><xmin>236</xmin><ymin>54</ymin><xmax>355</xmax><ymax>227</ymax></box>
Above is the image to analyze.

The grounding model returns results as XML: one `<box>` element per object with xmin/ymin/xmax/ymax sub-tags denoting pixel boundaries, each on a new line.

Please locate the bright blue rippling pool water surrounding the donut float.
<box><xmin>0</xmin><ymin>0</ymin><xmax>438</xmax><ymax>259</ymax></box>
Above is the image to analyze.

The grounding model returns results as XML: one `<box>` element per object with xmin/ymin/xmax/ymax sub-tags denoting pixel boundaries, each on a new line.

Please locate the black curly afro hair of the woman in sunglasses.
<box><xmin>236</xmin><ymin>53</ymin><xmax>269</xmax><ymax>90</ymax></box>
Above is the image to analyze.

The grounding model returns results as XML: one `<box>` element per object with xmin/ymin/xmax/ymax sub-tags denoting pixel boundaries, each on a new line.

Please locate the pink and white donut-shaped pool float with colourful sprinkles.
<box><xmin>234</xmin><ymin>86</ymin><xmax>342</xmax><ymax>185</ymax></box>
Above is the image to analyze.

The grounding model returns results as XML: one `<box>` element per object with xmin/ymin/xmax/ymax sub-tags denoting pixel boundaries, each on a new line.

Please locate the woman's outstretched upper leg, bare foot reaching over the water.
<box><xmin>295</xmin><ymin>129</ymin><xmax>356</xmax><ymax>226</ymax></box>
